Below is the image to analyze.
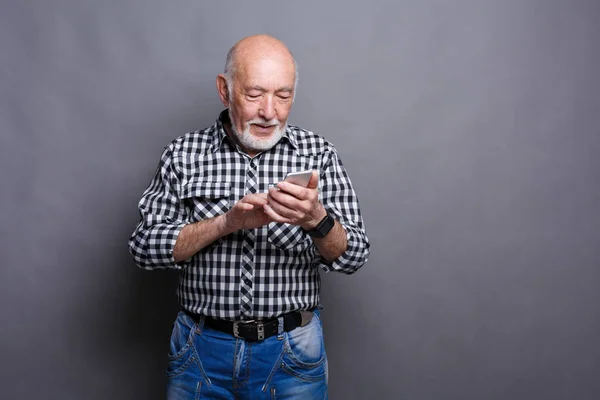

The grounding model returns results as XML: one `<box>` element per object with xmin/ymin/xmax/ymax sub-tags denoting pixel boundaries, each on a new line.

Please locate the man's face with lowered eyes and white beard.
<box><xmin>229</xmin><ymin>58</ymin><xmax>295</xmax><ymax>153</ymax></box>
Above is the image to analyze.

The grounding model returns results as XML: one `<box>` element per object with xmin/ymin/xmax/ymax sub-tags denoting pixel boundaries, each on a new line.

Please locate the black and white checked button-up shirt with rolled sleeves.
<box><xmin>129</xmin><ymin>112</ymin><xmax>370</xmax><ymax>319</ymax></box>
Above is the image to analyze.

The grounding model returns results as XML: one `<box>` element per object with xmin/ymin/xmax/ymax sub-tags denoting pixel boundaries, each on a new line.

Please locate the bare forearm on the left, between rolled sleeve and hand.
<box><xmin>173</xmin><ymin>215</ymin><xmax>233</xmax><ymax>262</ymax></box>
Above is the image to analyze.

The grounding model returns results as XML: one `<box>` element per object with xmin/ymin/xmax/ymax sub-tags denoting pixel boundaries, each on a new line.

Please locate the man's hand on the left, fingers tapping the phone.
<box><xmin>224</xmin><ymin>193</ymin><xmax>272</xmax><ymax>232</ymax></box>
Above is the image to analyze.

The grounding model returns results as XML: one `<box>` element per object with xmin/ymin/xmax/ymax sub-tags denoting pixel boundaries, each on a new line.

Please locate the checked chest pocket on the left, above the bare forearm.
<box><xmin>180</xmin><ymin>180</ymin><xmax>231</xmax><ymax>222</ymax></box>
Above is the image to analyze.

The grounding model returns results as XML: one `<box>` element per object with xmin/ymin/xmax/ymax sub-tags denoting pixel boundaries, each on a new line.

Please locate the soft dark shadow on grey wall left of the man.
<box><xmin>63</xmin><ymin>107</ymin><xmax>220</xmax><ymax>400</ymax></box>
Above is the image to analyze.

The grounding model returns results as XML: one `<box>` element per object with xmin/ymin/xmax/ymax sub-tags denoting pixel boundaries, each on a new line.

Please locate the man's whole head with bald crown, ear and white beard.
<box><xmin>217</xmin><ymin>35</ymin><xmax>298</xmax><ymax>154</ymax></box>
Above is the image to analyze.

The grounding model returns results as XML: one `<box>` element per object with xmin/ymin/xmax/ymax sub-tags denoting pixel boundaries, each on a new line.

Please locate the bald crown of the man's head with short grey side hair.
<box><xmin>224</xmin><ymin>35</ymin><xmax>298</xmax><ymax>94</ymax></box>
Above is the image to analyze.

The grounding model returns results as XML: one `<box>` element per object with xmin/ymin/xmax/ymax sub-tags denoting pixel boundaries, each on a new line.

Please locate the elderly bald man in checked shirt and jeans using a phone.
<box><xmin>129</xmin><ymin>35</ymin><xmax>369</xmax><ymax>400</ymax></box>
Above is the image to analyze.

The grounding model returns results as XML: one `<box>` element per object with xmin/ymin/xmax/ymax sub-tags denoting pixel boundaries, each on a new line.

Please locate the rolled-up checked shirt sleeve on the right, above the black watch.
<box><xmin>317</xmin><ymin>147</ymin><xmax>371</xmax><ymax>274</ymax></box>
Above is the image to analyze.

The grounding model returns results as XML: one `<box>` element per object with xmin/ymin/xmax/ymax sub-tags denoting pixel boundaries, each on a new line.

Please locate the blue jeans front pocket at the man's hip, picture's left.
<box><xmin>166</xmin><ymin>311</ymin><xmax>196</xmax><ymax>377</ymax></box>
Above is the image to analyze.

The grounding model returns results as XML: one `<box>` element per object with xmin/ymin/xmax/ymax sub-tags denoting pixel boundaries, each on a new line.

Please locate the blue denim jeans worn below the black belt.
<box><xmin>167</xmin><ymin>309</ymin><xmax>327</xmax><ymax>400</ymax></box>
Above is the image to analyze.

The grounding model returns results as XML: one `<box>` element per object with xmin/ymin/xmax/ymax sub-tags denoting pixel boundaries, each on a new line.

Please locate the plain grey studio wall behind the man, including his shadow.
<box><xmin>0</xmin><ymin>0</ymin><xmax>600</xmax><ymax>400</ymax></box>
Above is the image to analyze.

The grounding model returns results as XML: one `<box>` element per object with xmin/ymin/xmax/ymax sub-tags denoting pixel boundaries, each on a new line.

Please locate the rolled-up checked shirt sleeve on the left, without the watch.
<box><xmin>129</xmin><ymin>144</ymin><xmax>187</xmax><ymax>270</ymax></box>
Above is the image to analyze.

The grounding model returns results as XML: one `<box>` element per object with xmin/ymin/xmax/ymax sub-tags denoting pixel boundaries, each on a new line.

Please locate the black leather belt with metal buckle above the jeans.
<box><xmin>185</xmin><ymin>311</ymin><xmax>313</xmax><ymax>342</ymax></box>
